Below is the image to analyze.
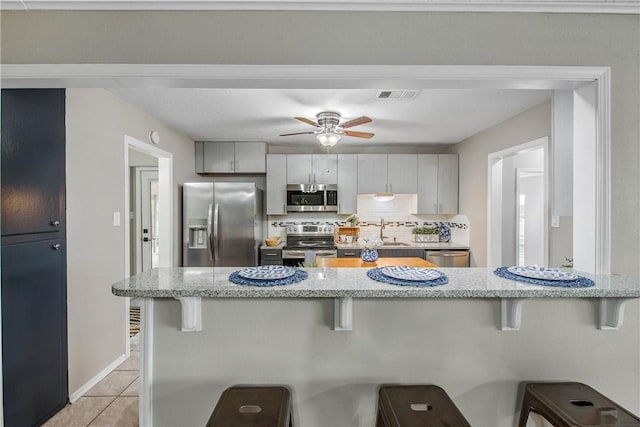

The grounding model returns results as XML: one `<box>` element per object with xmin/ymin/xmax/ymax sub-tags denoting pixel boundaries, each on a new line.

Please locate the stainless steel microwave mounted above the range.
<box><xmin>287</xmin><ymin>184</ymin><xmax>338</xmax><ymax>212</ymax></box>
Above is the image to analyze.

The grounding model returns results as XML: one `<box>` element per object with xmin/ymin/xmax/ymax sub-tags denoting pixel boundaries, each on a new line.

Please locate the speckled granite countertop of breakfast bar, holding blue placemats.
<box><xmin>112</xmin><ymin>267</ymin><xmax>640</xmax><ymax>298</ymax></box>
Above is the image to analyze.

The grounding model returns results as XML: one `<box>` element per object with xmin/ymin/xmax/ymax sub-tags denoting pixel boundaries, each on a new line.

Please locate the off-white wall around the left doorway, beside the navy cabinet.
<box><xmin>66</xmin><ymin>89</ymin><xmax>200</xmax><ymax>393</ymax></box>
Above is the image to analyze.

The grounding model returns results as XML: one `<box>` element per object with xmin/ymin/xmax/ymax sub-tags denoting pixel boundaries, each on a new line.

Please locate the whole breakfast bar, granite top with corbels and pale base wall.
<box><xmin>112</xmin><ymin>267</ymin><xmax>640</xmax><ymax>427</ymax></box>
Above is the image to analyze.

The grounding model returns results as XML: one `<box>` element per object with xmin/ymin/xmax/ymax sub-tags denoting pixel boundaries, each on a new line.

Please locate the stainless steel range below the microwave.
<box><xmin>282</xmin><ymin>224</ymin><xmax>338</xmax><ymax>266</ymax></box>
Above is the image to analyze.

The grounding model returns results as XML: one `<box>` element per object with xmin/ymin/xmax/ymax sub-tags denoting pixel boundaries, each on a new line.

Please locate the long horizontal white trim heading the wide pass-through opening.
<box><xmin>0</xmin><ymin>64</ymin><xmax>609</xmax><ymax>90</ymax></box>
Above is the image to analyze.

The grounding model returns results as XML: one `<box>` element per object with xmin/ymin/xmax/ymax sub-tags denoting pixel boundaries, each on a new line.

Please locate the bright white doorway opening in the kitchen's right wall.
<box><xmin>487</xmin><ymin>137</ymin><xmax>550</xmax><ymax>267</ymax></box>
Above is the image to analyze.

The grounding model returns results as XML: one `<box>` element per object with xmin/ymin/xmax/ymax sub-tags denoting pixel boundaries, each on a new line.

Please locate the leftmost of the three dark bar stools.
<box><xmin>207</xmin><ymin>386</ymin><xmax>293</xmax><ymax>427</ymax></box>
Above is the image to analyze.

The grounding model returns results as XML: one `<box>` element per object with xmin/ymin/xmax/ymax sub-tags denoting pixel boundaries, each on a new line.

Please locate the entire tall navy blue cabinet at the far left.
<box><xmin>1</xmin><ymin>89</ymin><xmax>68</xmax><ymax>427</ymax></box>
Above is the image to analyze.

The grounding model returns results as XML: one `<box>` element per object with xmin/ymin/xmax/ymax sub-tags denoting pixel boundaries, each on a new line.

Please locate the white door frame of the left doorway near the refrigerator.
<box><xmin>124</xmin><ymin>135</ymin><xmax>174</xmax><ymax>357</ymax></box>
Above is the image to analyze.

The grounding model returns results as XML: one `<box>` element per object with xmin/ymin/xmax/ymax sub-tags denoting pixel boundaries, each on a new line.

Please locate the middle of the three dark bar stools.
<box><xmin>376</xmin><ymin>385</ymin><xmax>471</xmax><ymax>427</ymax></box>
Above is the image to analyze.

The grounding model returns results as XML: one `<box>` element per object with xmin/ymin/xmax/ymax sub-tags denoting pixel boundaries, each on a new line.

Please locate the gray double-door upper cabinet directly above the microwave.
<box><xmin>287</xmin><ymin>154</ymin><xmax>338</xmax><ymax>184</ymax></box>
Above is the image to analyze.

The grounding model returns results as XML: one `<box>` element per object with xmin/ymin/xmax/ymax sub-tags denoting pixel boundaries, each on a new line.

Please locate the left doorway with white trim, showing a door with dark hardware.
<box><xmin>124</xmin><ymin>135</ymin><xmax>174</xmax><ymax>357</ymax></box>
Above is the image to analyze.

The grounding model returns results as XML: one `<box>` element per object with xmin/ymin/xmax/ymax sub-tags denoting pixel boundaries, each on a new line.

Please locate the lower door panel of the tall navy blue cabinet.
<box><xmin>2</xmin><ymin>239</ymin><xmax>67</xmax><ymax>426</ymax></box>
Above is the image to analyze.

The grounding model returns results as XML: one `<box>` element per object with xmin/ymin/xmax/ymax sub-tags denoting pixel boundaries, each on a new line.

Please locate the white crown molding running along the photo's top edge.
<box><xmin>0</xmin><ymin>0</ymin><xmax>640</xmax><ymax>14</ymax></box>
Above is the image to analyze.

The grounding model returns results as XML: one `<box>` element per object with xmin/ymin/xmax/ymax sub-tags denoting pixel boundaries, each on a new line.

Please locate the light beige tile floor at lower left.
<box><xmin>44</xmin><ymin>334</ymin><xmax>140</xmax><ymax>427</ymax></box>
